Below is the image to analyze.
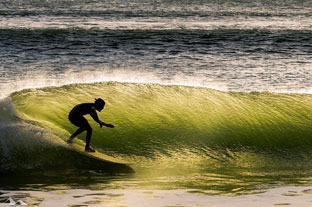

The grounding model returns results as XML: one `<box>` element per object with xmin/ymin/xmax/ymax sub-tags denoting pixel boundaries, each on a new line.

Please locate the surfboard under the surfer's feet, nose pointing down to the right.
<box><xmin>68</xmin><ymin>143</ymin><xmax>130</xmax><ymax>165</ymax></box>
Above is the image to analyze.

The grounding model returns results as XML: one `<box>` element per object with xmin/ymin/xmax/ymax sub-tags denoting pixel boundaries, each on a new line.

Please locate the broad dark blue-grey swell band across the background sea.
<box><xmin>0</xmin><ymin>27</ymin><xmax>312</xmax><ymax>54</ymax></box>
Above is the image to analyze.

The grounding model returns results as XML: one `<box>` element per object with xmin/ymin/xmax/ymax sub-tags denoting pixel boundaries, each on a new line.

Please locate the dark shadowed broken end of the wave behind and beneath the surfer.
<box><xmin>0</xmin><ymin>99</ymin><xmax>133</xmax><ymax>174</ymax></box>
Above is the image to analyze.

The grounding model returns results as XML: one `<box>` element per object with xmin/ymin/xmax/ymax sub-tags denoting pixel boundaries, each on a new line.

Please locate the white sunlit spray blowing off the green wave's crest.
<box><xmin>0</xmin><ymin>68</ymin><xmax>228</xmax><ymax>98</ymax></box>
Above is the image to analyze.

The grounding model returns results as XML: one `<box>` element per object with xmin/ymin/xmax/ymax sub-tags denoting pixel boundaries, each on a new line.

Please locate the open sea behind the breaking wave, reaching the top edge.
<box><xmin>0</xmin><ymin>0</ymin><xmax>312</xmax><ymax>96</ymax></box>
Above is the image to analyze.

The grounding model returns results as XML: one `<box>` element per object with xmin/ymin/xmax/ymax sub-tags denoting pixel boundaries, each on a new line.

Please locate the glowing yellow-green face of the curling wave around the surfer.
<box><xmin>11</xmin><ymin>82</ymin><xmax>312</xmax><ymax>173</ymax></box>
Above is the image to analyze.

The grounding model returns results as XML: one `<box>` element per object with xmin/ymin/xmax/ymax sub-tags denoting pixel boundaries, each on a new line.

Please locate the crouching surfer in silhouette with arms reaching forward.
<box><xmin>67</xmin><ymin>98</ymin><xmax>114</xmax><ymax>152</ymax></box>
